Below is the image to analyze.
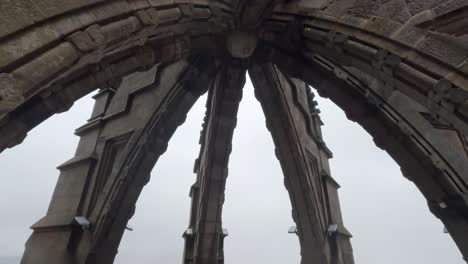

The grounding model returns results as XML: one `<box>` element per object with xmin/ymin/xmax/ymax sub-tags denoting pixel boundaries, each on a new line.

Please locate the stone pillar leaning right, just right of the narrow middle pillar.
<box><xmin>249</xmin><ymin>58</ymin><xmax>352</xmax><ymax>264</ymax></box>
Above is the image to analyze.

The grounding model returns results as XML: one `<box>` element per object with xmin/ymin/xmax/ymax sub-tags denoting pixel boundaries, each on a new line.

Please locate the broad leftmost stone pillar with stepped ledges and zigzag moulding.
<box><xmin>21</xmin><ymin>57</ymin><xmax>211</xmax><ymax>264</ymax></box>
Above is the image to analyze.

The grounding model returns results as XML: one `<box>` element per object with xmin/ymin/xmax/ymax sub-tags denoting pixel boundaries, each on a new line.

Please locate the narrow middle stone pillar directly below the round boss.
<box><xmin>184</xmin><ymin>60</ymin><xmax>246</xmax><ymax>264</ymax></box>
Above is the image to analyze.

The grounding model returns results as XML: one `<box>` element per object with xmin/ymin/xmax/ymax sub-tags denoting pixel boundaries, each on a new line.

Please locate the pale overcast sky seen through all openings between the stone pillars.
<box><xmin>0</xmin><ymin>75</ymin><xmax>464</xmax><ymax>264</ymax></box>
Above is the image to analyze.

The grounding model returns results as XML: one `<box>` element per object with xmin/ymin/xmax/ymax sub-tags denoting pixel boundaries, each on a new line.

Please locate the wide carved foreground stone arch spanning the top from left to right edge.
<box><xmin>0</xmin><ymin>0</ymin><xmax>468</xmax><ymax>264</ymax></box>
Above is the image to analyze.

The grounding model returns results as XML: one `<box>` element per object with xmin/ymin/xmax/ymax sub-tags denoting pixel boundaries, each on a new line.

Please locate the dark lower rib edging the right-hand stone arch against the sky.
<box><xmin>264</xmin><ymin>47</ymin><xmax>468</xmax><ymax>258</ymax></box>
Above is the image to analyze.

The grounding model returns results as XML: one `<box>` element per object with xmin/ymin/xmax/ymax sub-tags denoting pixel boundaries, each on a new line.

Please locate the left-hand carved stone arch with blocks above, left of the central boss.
<box><xmin>0</xmin><ymin>0</ymin><xmax>232</xmax><ymax>151</ymax></box>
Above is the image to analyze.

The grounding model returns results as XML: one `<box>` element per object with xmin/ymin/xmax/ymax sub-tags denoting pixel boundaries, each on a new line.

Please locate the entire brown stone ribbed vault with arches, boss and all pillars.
<box><xmin>0</xmin><ymin>0</ymin><xmax>468</xmax><ymax>264</ymax></box>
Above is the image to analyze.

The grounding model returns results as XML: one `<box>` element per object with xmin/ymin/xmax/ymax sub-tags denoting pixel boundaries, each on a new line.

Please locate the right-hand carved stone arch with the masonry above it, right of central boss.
<box><xmin>256</xmin><ymin>1</ymin><xmax>468</xmax><ymax>259</ymax></box>
